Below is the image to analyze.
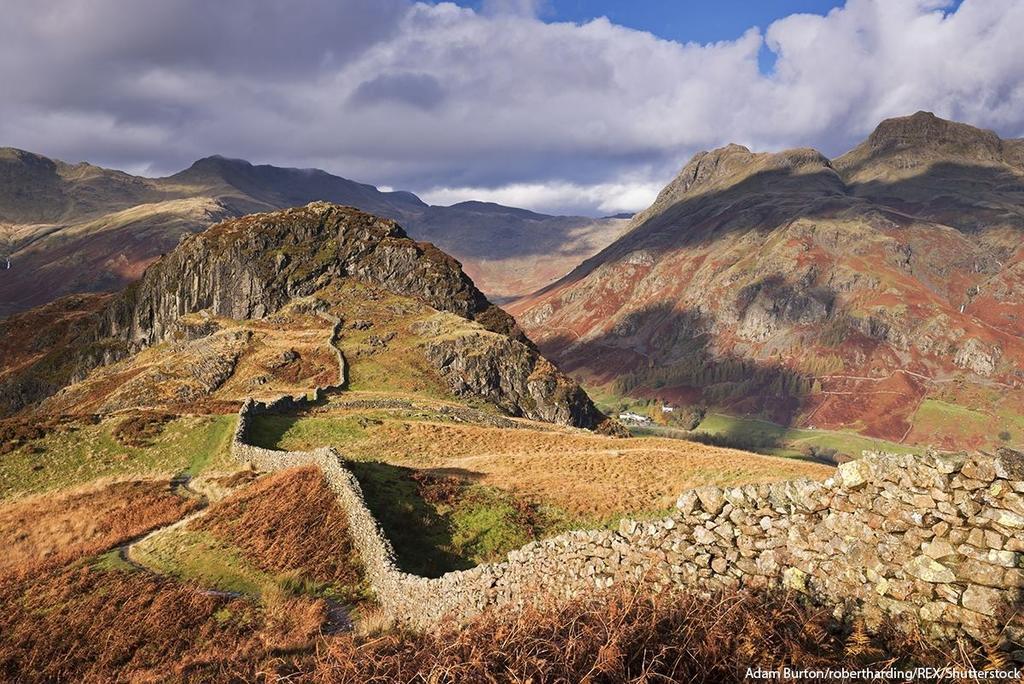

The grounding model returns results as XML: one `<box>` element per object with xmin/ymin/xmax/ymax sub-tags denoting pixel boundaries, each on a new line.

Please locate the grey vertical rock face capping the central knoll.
<box><xmin>100</xmin><ymin>203</ymin><xmax>526</xmax><ymax>346</ymax></box>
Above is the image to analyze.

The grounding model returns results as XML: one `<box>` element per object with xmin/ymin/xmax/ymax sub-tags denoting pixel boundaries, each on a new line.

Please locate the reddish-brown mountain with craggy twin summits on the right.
<box><xmin>510</xmin><ymin>112</ymin><xmax>1024</xmax><ymax>454</ymax></box>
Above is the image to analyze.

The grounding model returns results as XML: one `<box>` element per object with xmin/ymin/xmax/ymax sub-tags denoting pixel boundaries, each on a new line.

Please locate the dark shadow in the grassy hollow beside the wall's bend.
<box><xmin>346</xmin><ymin>461</ymin><xmax>474</xmax><ymax>578</ymax></box>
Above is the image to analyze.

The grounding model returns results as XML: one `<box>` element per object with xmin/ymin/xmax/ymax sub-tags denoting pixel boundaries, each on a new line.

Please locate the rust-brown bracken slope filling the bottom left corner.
<box><xmin>0</xmin><ymin>564</ymin><xmax>323</xmax><ymax>682</ymax></box>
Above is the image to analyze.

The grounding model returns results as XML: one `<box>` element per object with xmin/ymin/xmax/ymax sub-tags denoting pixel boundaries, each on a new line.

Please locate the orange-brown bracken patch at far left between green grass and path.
<box><xmin>0</xmin><ymin>480</ymin><xmax>196</xmax><ymax>574</ymax></box>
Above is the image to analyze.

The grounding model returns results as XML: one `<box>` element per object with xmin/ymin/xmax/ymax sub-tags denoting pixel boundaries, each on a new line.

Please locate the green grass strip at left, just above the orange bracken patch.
<box><xmin>0</xmin><ymin>416</ymin><xmax>234</xmax><ymax>501</ymax></box>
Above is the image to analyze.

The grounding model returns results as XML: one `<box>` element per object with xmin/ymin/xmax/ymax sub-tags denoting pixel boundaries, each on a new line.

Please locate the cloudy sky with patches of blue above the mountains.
<box><xmin>0</xmin><ymin>0</ymin><xmax>1024</xmax><ymax>215</ymax></box>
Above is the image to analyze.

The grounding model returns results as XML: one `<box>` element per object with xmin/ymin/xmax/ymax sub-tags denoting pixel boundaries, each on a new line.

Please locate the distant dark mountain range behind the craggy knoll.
<box><xmin>0</xmin><ymin>148</ymin><xmax>627</xmax><ymax>316</ymax></box>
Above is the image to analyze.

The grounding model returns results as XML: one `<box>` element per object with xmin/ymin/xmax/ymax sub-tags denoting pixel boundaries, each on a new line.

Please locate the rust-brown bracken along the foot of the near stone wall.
<box><xmin>309</xmin><ymin>588</ymin><xmax>991</xmax><ymax>684</ymax></box>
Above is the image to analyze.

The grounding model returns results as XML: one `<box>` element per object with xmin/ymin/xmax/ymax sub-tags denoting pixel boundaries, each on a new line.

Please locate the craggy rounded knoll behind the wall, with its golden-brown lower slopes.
<box><xmin>0</xmin><ymin>198</ymin><xmax>604</xmax><ymax>428</ymax></box>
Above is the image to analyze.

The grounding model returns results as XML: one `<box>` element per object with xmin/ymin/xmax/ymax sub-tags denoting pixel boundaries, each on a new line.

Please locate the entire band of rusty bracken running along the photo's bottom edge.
<box><xmin>0</xmin><ymin>565</ymin><xmax>1001</xmax><ymax>684</ymax></box>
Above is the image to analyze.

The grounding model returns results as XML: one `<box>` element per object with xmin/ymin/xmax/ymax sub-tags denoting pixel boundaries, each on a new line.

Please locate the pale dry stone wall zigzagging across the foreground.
<box><xmin>232</xmin><ymin>389</ymin><xmax>1024</xmax><ymax>658</ymax></box>
